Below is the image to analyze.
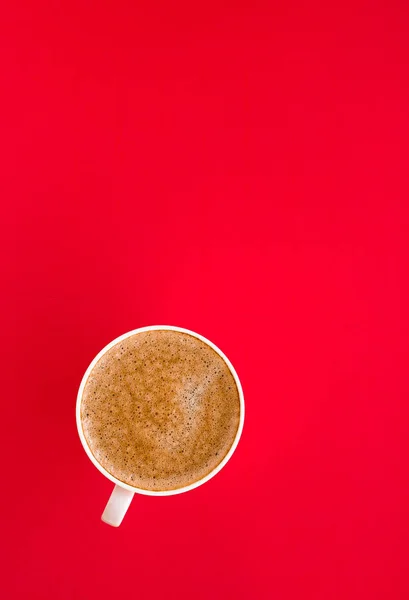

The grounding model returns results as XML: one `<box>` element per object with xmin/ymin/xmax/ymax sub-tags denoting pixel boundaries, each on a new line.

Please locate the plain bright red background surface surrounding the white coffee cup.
<box><xmin>0</xmin><ymin>0</ymin><xmax>409</xmax><ymax>600</ymax></box>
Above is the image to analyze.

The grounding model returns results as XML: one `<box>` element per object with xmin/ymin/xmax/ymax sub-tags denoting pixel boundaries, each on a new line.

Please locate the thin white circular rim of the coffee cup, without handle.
<box><xmin>76</xmin><ymin>325</ymin><xmax>244</xmax><ymax>496</ymax></box>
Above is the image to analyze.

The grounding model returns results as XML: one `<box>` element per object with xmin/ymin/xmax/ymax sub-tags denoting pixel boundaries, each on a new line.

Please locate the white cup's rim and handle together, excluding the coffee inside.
<box><xmin>76</xmin><ymin>325</ymin><xmax>244</xmax><ymax>527</ymax></box>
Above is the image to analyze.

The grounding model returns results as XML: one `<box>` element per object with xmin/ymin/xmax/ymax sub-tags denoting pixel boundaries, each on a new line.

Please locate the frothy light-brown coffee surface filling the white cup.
<box><xmin>81</xmin><ymin>330</ymin><xmax>240</xmax><ymax>491</ymax></box>
